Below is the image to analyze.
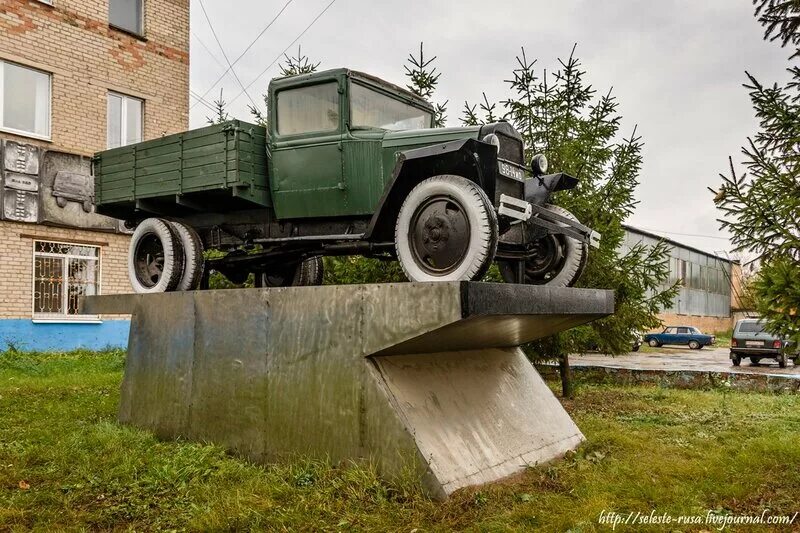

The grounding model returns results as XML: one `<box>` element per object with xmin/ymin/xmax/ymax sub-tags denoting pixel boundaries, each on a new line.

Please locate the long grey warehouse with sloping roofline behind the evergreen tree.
<box><xmin>622</xmin><ymin>226</ymin><xmax>741</xmax><ymax>333</ymax></box>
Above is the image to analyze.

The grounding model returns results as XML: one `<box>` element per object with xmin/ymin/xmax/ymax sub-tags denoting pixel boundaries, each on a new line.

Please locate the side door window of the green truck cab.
<box><xmin>277</xmin><ymin>81</ymin><xmax>339</xmax><ymax>135</ymax></box>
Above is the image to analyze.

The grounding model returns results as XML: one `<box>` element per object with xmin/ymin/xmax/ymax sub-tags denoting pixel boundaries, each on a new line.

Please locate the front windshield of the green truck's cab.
<box><xmin>350</xmin><ymin>83</ymin><xmax>431</xmax><ymax>131</ymax></box>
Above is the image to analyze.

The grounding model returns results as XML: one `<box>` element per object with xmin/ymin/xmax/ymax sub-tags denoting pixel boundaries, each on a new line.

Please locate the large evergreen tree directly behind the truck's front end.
<box><xmin>462</xmin><ymin>47</ymin><xmax>678</xmax><ymax>396</ymax></box>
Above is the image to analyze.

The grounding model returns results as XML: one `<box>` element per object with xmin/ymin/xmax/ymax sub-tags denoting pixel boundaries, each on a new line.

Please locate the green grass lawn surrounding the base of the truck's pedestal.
<box><xmin>0</xmin><ymin>351</ymin><xmax>800</xmax><ymax>531</ymax></box>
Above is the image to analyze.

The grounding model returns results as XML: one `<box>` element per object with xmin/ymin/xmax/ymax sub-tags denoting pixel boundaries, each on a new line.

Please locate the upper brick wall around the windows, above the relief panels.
<box><xmin>0</xmin><ymin>0</ymin><xmax>189</xmax><ymax>155</ymax></box>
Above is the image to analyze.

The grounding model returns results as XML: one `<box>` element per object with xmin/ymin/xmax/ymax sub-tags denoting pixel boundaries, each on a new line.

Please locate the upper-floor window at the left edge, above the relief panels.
<box><xmin>0</xmin><ymin>61</ymin><xmax>50</xmax><ymax>139</ymax></box>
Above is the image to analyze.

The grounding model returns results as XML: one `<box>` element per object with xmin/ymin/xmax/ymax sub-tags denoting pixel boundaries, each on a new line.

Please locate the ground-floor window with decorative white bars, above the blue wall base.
<box><xmin>33</xmin><ymin>241</ymin><xmax>100</xmax><ymax>318</ymax></box>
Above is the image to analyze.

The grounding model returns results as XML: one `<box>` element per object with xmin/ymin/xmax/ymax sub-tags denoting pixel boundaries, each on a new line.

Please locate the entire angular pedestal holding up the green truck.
<box><xmin>84</xmin><ymin>283</ymin><xmax>613</xmax><ymax>498</ymax></box>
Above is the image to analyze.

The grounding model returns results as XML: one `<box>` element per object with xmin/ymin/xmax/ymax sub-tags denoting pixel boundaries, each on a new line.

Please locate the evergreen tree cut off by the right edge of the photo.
<box><xmin>712</xmin><ymin>0</ymin><xmax>800</xmax><ymax>340</ymax></box>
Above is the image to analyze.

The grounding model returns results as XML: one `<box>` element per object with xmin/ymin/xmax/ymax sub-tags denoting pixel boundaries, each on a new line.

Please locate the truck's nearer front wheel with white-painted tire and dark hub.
<box><xmin>395</xmin><ymin>175</ymin><xmax>498</xmax><ymax>281</ymax></box>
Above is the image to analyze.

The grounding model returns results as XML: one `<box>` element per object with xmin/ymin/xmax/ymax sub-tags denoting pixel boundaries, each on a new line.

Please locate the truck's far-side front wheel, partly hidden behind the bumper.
<box><xmin>497</xmin><ymin>205</ymin><xmax>589</xmax><ymax>287</ymax></box>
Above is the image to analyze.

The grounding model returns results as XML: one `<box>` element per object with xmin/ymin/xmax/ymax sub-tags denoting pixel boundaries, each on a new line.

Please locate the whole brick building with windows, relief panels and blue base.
<box><xmin>0</xmin><ymin>0</ymin><xmax>189</xmax><ymax>350</ymax></box>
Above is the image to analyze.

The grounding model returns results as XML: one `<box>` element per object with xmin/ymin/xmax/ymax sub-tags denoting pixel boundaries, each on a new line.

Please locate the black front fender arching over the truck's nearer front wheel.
<box><xmin>364</xmin><ymin>139</ymin><xmax>497</xmax><ymax>242</ymax></box>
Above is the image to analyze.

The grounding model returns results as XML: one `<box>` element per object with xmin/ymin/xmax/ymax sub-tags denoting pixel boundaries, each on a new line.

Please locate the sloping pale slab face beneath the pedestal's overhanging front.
<box><xmin>375</xmin><ymin>348</ymin><xmax>583</xmax><ymax>494</ymax></box>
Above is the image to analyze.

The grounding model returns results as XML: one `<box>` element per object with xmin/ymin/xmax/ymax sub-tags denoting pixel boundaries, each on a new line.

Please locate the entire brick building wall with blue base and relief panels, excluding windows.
<box><xmin>0</xmin><ymin>0</ymin><xmax>189</xmax><ymax>351</ymax></box>
